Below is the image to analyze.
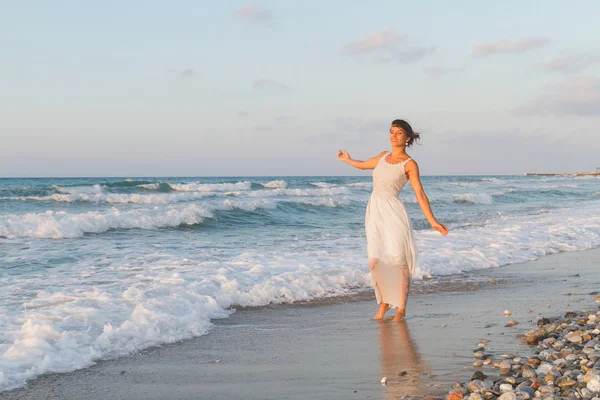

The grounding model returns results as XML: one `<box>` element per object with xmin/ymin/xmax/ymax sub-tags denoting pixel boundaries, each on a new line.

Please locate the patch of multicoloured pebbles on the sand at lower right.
<box><xmin>446</xmin><ymin>308</ymin><xmax>600</xmax><ymax>400</ymax></box>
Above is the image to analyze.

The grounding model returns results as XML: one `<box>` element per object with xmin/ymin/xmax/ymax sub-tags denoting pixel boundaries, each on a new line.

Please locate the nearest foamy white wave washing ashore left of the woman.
<box><xmin>0</xmin><ymin>251</ymin><xmax>371</xmax><ymax>391</ymax></box>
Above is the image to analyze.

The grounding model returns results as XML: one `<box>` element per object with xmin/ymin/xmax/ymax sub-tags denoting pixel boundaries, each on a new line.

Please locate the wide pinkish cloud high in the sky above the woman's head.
<box><xmin>342</xmin><ymin>29</ymin><xmax>435</xmax><ymax>64</ymax></box>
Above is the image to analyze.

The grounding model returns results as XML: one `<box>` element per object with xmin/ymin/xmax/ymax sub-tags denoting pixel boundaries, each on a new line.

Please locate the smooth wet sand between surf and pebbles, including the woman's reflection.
<box><xmin>0</xmin><ymin>249</ymin><xmax>600</xmax><ymax>400</ymax></box>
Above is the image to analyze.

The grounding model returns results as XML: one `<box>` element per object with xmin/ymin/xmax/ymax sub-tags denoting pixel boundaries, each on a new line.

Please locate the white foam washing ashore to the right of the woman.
<box><xmin>417</xmin><ymin>202</ymin><xmax>600</xmax><ymax>275</ymax></box>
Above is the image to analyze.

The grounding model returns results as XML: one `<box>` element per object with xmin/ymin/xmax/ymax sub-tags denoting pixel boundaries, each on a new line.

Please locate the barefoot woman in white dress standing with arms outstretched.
<box><xmin>338</xmin><ymin>119</ymin><xmax>448</xmax><ymax>322</ymax></box>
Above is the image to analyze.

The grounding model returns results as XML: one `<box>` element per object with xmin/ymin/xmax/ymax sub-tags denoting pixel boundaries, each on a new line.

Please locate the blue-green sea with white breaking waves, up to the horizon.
<box><xmin>0</xmin><ymin>176</ymin><xmax>600</xmax><ymax>391</ymax></box>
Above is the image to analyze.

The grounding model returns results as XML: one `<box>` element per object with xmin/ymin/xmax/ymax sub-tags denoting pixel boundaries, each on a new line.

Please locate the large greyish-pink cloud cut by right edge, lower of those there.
<box><xmin>515</xmin><ymin>77</ymin><xmax>600</xmax><ymax>117</ymax></box>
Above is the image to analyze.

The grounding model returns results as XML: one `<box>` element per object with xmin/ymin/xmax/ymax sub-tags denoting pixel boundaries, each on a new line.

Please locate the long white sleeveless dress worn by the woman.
<box><xmin>365</xmin><ymin>153</ymin><xmax>417</xmax><ymax>307</ymax></box>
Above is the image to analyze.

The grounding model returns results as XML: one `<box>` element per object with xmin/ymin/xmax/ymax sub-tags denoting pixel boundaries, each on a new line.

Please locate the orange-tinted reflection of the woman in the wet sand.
<box><xmin>380</xmin><ymin>321</ymin><xmax>428</xmax><ymax>399</ymax></box>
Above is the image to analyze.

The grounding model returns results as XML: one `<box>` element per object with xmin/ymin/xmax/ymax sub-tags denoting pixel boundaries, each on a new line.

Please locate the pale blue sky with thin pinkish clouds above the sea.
<box><xmin>0</xmin><ymin>0</ymin><xmax>600</xmax><ymax>177</ymax></box>
